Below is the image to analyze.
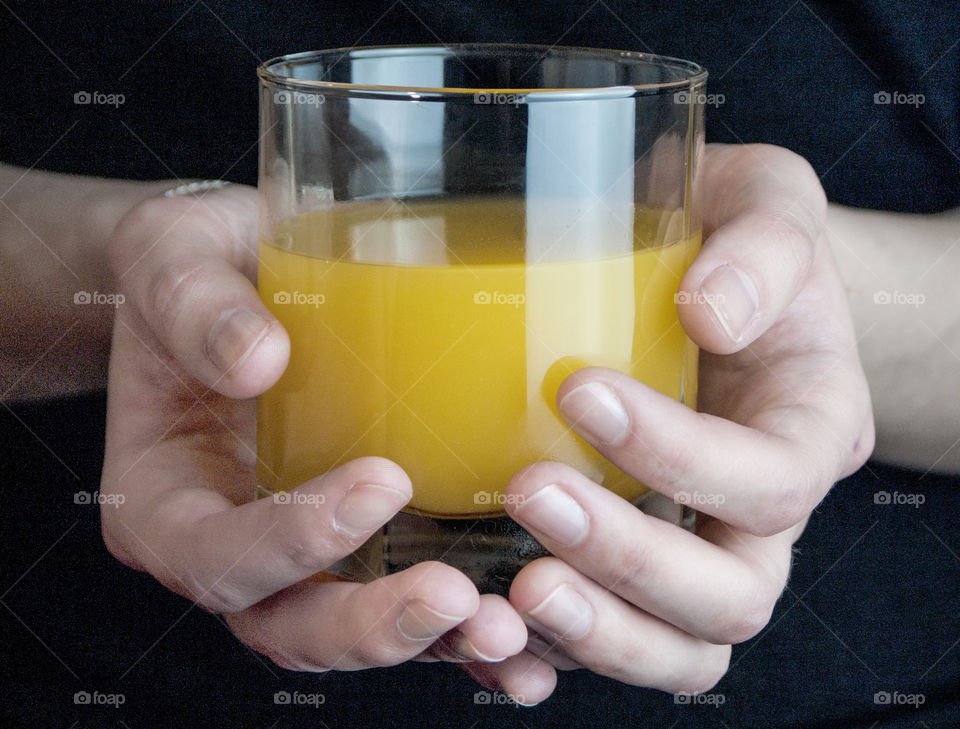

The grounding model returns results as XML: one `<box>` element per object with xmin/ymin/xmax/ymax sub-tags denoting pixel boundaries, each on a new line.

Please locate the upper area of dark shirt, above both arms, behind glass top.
<box><xmin>0</xmin><ymin>0</ymin><xmax>960</xmax><ymax>212</ymax></box>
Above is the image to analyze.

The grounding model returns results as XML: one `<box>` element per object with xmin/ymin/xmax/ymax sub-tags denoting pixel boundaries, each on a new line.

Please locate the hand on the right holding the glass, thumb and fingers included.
<box><xmin>480</xmin><ymin>145</ymin><xmax>874</xmax><ymax>701</ymax></box>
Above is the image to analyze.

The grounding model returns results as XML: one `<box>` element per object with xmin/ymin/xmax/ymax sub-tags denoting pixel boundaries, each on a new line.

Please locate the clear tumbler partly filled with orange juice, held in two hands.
<box><xmin>257</xmin><ymin>44</ymin><xmax>706</xmax><ymax>593</ymax></box>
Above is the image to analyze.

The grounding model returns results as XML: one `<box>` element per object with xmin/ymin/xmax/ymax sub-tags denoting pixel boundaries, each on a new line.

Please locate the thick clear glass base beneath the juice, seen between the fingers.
<box><xmin>258</xmin><ymin>487</ymin><xmax>696</xmax><ymax>597</ymax></box>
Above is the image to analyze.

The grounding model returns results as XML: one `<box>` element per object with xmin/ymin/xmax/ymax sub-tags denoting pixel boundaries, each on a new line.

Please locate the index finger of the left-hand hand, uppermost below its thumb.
<box><xmin>103</xmin><ymin>453</ymin><xmax>412</xmax><ymax>613</ymax></box>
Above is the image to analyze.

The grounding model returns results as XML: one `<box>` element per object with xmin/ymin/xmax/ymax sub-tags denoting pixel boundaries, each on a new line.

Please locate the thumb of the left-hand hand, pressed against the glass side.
<box><xmin>110</xmin><ymin>185</ymin><xmax>290</xmax><ymax>398</ymax></box>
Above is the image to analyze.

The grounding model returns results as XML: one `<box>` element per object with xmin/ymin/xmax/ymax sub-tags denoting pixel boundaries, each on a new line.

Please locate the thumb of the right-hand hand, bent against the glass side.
<box><xmin>677</xmin><ymin>145</ymin><xmax>826</xmax><ymax>354</ymax></box>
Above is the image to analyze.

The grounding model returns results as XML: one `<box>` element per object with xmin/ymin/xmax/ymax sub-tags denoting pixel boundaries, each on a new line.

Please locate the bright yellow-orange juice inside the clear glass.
<box><xmin>257</xmin><ymin>197</ymin><xmax>700</xmax><ymax>517</ymax></box>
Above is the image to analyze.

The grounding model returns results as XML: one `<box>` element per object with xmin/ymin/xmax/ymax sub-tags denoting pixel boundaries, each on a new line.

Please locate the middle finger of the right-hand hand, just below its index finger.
<box><xmin>506</xmin><ymin>463</ymin><xmax>798</xmax><ymax>644</ymax></box>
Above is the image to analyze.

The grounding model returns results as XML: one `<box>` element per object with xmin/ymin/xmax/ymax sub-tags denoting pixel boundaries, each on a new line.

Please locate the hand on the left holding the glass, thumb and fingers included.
<box><xmin>101</xmin><ymin>185</ymin><xmax>529</xmax><ymax>671</ymax></box>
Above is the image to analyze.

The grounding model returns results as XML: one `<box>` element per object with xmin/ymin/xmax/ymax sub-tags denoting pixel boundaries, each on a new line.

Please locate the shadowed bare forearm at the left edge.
<box><xmin>0</xmin><ymin>165</ymin><xmax>171</xmax><ymax>401</ymax></box>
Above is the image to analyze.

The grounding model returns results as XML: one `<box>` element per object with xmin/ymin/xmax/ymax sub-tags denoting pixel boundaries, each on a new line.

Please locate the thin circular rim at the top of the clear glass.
<box><xmin>257</xmin><ymin>43</ymin><xmax>707</xmax><ymax>102</ymax></box>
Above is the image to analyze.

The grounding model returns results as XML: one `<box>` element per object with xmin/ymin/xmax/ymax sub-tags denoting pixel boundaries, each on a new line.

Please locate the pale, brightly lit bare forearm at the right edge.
<box><xmin>827</xmin><ymin>204</ymin><xmax>960</xmax><ymax>473</ymax></box>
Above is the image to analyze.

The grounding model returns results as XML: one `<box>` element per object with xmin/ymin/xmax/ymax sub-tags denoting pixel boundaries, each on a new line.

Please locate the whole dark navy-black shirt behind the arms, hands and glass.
<box><xmin>0</xmin><ymin>0</ymin><xmax>960</xmax><ymax>729</ymax></box>
